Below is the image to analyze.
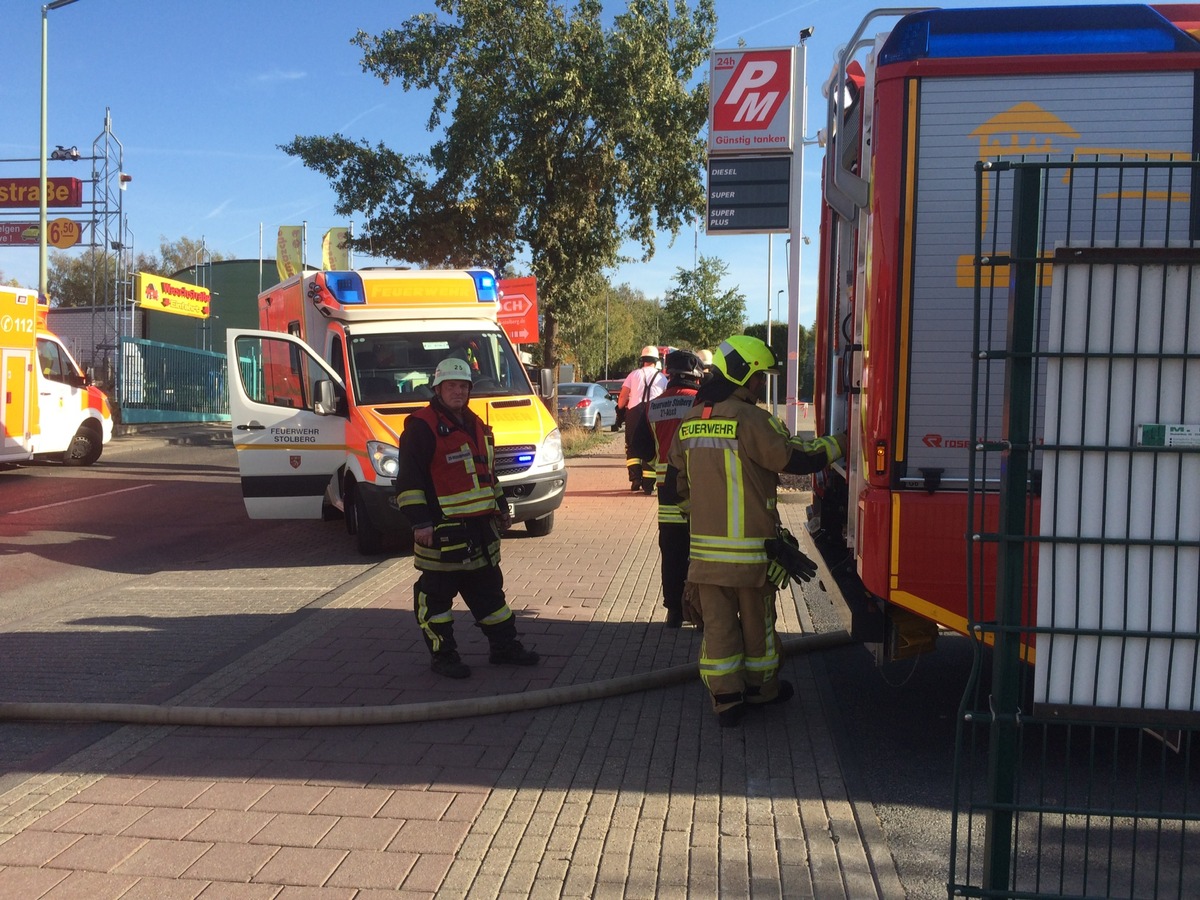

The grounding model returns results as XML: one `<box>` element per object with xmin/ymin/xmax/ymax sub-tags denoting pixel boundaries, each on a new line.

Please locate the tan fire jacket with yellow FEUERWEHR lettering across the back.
<box><xmin>664</xmin><ymin>388</ymin><xmax>841</xmax><ymax>587</ymax></box>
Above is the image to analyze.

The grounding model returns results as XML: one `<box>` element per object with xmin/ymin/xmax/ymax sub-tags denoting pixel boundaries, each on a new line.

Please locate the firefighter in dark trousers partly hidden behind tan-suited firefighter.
<box><xmin>632</xmin><ymin>350</ymin><xmax>704</xmax><ymax>628</ymax></box>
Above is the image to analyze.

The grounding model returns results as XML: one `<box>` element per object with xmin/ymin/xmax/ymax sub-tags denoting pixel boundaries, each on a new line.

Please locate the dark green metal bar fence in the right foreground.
<box><xmin>948</xmin><ymin>161</ymin><xmax>1200</xmax><ymax>898</ymax></box>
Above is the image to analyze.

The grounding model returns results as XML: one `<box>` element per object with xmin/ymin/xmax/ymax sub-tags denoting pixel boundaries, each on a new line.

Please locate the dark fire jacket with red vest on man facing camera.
<box><xmin>396</xmin><ymin>400</ymin><xmax>508</xmax><ymax>569</ymax></box>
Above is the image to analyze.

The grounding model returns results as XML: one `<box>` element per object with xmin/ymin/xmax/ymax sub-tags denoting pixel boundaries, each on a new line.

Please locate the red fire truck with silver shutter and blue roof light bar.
<box><xmin>811</xmin><ymin>5</ymin><xmax>1200</xmax><ymax>660</ymax></box>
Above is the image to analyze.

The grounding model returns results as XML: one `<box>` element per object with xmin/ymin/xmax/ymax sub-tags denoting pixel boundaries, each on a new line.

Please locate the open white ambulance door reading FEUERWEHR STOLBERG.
<box><xmin>226</xmin><ymin>329</ymin><xmax>347</xmax><ymax>518</ymax></box>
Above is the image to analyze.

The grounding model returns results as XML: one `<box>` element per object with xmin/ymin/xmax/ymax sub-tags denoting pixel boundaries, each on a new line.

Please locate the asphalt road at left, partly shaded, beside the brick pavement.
<box><xmin>0</xmin><ymin>426</ymin><xmax>385</xmax><ymax>790</ymax></box>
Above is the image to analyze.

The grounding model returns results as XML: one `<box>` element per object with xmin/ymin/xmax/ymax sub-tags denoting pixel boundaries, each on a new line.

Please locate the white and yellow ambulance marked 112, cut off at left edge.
<box><xmin>0</xmin><ymin>287</ymin><xmax>113</xmax><ymax>466</ymax></box>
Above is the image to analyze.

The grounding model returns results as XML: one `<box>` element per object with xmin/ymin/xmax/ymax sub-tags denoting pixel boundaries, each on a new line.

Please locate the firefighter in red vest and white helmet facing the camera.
<box><xmin>396</xmin><ymin>358</ymin><xmax>539</xmax><ymax>678</ymax></box>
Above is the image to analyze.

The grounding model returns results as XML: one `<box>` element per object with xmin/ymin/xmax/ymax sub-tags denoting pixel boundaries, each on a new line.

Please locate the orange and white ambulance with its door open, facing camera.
<box><xmin>227</xmin><ymin>268</ymin><xmax>566</xmax><ymax>556</ymax></box>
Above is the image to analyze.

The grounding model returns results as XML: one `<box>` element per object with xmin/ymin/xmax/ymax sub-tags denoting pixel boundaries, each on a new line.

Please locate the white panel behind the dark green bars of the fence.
<box><xmin>1036</xmin><ymin>259</ymin><xmax>1200</xmax><ymax>710</ymax></box>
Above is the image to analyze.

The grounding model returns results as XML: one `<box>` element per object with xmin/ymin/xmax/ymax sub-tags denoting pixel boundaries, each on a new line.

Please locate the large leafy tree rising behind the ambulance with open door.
<box><xmin>281</xmin><ymin>0</ymin><xmax>716</xmax><ymax>365</ymax></box>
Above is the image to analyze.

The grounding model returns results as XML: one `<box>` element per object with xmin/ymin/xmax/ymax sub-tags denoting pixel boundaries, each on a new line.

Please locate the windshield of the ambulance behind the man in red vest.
<box><xmin>350</xmin><ymin>330</ymin><xmax>533</xmax><ymax>404</ymax></box>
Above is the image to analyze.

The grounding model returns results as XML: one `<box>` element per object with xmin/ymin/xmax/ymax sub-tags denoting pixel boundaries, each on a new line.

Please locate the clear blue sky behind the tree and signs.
<box><xmin>0</xmin><ymin>0</ymin><xmax>1113</xmax><ymax>324</ymax></box>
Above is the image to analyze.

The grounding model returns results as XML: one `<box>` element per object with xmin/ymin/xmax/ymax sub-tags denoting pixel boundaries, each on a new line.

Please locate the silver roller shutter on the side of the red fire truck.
<box><xmin>906</xmin><ymin>72</ymin><xmax>1193</xmax><ymax>484</ymax></box>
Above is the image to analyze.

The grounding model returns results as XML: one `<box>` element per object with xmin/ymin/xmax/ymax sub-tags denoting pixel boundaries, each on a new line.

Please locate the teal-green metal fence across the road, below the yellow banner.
<box><xmin>116</xmin><ymin>337</ymin><xmax>229</xmax><ymax>424</ymax></box>
